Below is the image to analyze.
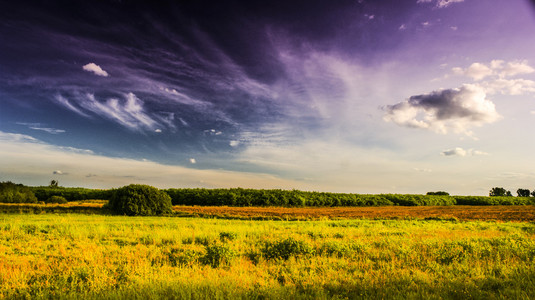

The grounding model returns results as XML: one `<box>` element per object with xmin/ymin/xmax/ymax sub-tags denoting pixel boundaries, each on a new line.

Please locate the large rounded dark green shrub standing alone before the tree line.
<box><xmin>106</xmin><ymin>184</ymin><xmax>172</xmax><ymax>216</ymax></box>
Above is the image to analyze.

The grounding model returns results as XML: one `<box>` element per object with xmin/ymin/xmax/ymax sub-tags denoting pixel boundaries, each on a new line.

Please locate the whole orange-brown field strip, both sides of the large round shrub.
<box><xmin>0</xmin><ymin>201</ymin><xmax>535</xmax><ymax>222</ymax></box>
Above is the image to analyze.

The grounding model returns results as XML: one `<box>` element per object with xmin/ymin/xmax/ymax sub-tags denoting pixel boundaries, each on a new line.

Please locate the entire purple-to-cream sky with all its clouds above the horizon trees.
<box><xmin>0</xmin><ymin>0</ymin><xmax>535</xmax><ymax>195</ymax></box>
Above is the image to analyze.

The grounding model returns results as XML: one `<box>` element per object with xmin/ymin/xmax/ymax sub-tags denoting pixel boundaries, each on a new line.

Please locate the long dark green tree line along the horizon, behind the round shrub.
<box><xmin>0</xmin><ymin>182</ymin><xmax>535</xmax><ymax>207</ymax></box>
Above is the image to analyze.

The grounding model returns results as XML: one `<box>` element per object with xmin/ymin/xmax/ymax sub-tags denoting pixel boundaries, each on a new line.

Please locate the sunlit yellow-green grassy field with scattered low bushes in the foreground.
<box><xmin>0</xmin><ymin>214</ymin><xmax>535</xmax><ymax>299</ymax></box>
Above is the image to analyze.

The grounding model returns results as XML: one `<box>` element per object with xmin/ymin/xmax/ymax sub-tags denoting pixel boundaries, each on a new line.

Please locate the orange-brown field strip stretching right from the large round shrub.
<box><xmin>173</xmin><ymin>205</ymin><xmax>535</xmax><ymax>222</ymax></box>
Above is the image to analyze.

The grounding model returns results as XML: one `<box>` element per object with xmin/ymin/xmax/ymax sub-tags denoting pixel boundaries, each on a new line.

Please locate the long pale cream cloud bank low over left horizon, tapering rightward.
<box><xmin>0</xmin><ymin>131</ymin><xmax>306</xmax><ymax>189</ymax></box>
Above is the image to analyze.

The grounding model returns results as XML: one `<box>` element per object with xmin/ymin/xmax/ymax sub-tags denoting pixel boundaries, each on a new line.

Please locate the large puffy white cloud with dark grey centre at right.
<box><xmin>383</xmin><ymin>84</ymin><xmax>501</xmax><ymax>135</ymax></box>
